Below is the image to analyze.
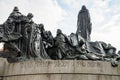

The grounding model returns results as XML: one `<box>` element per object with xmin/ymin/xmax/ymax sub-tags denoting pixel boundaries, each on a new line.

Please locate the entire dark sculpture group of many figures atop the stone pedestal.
<box><xmin>0</xmin><ymin>6</ymin><xmax>120</xmax><ymax>66</ymax></box>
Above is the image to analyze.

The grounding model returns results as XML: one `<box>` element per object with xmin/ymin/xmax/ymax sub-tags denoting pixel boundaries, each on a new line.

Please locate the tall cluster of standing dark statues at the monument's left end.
<box><xmin>0</xmin><ymin>7</ymin><xmax>49</xmax><ymax>62</ymax></box>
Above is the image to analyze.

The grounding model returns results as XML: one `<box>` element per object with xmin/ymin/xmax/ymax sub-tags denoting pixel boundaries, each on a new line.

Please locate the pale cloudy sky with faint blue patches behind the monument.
<box><xmin>0</xmin><ymin>0</ymin><xmax>120</xmax><ymax>50</ymax></box>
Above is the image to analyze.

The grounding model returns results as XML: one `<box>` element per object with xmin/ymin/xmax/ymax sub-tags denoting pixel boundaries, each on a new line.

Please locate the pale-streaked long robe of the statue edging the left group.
<box><xmin>28</xmin><ymin>23</ymin><xmax>50</xmax><ymax>59</ymax></box>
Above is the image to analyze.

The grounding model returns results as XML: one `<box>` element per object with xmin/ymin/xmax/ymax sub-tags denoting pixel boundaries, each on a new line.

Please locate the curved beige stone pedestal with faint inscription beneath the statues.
<box><xmin>0</xmin><ymin>60</ymin><xmax>120</xmax><ymax>80</ymax></box>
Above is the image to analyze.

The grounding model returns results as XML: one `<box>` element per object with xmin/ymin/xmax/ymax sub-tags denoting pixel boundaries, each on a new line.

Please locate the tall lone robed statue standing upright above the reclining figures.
<box><xmin>76</xmin><ymin>6</ymin><xmax>92</xmax><ymax>41</ymax></box>
